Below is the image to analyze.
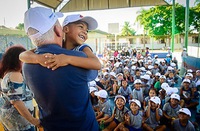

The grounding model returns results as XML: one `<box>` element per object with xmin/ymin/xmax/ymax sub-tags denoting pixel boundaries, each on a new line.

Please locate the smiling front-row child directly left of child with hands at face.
<box><xmin>114</xmin><ymin>99</ymin><xmax>143</xmax><ymax>131</ymax></box>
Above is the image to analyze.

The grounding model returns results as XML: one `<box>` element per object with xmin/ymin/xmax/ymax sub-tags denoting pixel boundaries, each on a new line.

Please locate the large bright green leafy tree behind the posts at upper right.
<box><xmin>136</xmin><ymin>4</ymin><xmax>200</xmax><ymax>39</ymax></box>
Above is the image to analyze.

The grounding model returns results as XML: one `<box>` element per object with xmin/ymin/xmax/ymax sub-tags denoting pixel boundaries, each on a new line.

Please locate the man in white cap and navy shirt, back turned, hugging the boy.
<box><xmin>23</xmin><ymin>7</ymin><xmax>98</xmax><ymax>131</ymax></box>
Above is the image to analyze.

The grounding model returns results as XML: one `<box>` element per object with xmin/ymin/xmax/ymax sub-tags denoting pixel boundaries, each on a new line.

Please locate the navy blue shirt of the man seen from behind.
<box><xmin>23</xmin><ymin>44</ymin><xmax>98</xmax><ymax>131</ymax></box>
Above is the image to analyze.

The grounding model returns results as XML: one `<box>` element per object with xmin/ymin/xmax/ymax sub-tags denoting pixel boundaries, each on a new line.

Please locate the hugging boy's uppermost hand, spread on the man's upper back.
<box><xmin>45</xmin><ymin>54</ymin><xmax>69</xmax><ymax>70</ymax></box>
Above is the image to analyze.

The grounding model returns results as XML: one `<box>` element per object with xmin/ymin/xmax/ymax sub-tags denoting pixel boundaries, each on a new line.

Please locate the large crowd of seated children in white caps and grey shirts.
<box><xmin>89</xmin><ymin>48</ymin><xmax>200</xmax><ymax>131</ymax></box>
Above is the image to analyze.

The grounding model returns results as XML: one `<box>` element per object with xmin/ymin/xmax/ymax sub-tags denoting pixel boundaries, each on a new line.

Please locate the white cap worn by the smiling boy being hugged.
<box><xmin>62</xmin><ymin>14</ymin><xmax>98</xmax><ymax>30</ymax></box>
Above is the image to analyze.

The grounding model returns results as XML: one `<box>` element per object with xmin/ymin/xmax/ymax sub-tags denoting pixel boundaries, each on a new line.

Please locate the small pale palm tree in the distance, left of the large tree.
<box><xmin>121</xmin><ymin>21</ymin><xmax>136</xmax><ymax>36</ymax></box>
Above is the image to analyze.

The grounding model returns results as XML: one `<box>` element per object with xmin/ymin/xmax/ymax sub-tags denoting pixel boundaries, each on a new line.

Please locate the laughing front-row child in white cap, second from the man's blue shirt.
<box><xmin>103</xmin><ymin>95</ymin><xmax>129</xmax><ymax>131</ymax></box>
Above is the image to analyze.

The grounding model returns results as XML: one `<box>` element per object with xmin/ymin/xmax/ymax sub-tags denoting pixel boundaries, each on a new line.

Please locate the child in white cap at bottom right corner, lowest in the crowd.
<box><xmin>172</xmin><ymin>108</ymin><xmax>195</xmax><ymax>131</ymax></box>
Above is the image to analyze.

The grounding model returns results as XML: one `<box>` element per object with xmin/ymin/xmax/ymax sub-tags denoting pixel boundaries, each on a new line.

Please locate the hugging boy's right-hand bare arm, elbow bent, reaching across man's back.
<box><xmin>46</xmin><ymin>47</ymin><xmax>101</xmax><ymax>70</ymax></box>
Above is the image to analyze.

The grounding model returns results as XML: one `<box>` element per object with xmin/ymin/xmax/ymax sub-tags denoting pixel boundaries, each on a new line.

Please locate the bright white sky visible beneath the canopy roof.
<box><xmin>0</xmin><ymin>0</ymin><xmax>194</xmax><ymax>32</ymax></box>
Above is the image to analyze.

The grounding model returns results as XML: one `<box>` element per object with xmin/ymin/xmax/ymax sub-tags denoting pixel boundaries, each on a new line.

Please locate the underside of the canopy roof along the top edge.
<box><xmin>33</xmin><ymin>0</ymin><xmax>167</xmax><ymax>13</ymax></box>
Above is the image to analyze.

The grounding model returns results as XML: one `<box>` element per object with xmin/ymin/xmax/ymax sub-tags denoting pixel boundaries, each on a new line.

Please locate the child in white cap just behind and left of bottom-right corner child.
<box><xmin>163</xmin><ymin>94</ymin><xmax>181</xmax><ymax>129</ymax></box>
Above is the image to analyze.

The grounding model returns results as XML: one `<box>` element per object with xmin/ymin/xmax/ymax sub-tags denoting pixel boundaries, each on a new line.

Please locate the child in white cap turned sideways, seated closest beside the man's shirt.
<box><xmin>94</xmin><ymin>90</ymin><xmax>111</xmax><ymax>122</ymax></box>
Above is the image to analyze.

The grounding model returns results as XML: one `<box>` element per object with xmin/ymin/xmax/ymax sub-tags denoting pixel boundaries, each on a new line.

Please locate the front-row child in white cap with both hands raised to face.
<box><xmin>143</xmin><ymin>96</ymin><xmax>166</xmax><ymax>131</ymax></box>
